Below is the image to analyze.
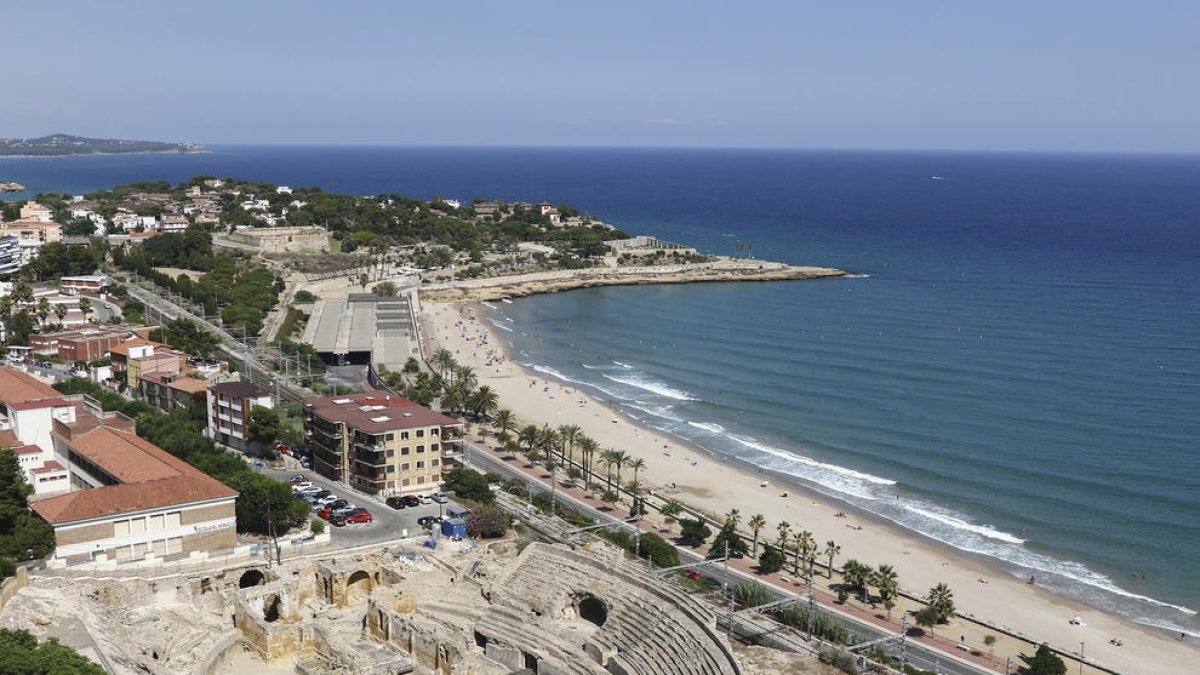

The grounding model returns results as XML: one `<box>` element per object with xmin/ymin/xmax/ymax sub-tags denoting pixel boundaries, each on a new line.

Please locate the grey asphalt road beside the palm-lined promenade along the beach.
<box><xmin>463</xmin><ymin>441</ymin><xmax>991</xmax><ymax>675</ymax></box>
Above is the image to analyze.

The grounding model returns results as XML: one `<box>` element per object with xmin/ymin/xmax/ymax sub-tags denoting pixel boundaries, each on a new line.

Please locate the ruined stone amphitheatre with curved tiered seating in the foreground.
<box><xmin>0</xmin><ymin>539</ymin><xmax>825</xmax><ymax>675</ymax></box>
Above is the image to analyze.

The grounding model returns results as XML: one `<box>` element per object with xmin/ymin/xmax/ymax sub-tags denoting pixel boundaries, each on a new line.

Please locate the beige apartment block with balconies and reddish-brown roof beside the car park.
<box><xmin>305</xmin><ymin>390</ymin><xmax>463</xmax><ymax>496</ymax></box>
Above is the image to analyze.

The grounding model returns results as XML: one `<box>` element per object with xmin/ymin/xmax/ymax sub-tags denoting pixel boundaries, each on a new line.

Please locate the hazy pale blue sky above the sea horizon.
<box><xmin>0</xmin><ymin>0</ymin><xmax>1200</xmax><ymax>151</ymax></box>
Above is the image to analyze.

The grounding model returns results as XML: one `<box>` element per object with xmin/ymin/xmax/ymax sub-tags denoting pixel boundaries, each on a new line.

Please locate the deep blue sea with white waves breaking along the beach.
<box><xmin>0</xmin><ymin>147</ymin><xmax>1200</xmax><ymax>635</ymax></box>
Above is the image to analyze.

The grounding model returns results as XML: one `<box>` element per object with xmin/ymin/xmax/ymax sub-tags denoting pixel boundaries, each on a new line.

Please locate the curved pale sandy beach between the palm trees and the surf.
<box><xmin>420</xmin><ymin>295</ymin><xmax>1200</xmax><ymax>674</ymax></box>
